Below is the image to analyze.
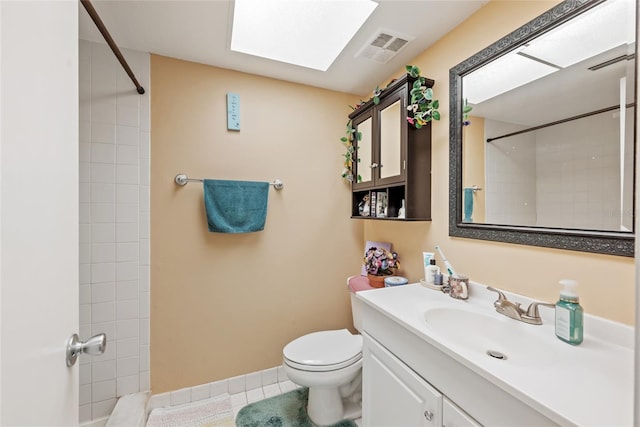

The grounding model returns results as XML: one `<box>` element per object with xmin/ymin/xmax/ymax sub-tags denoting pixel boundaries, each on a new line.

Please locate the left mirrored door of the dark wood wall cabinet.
<box><xmin>353</xmin><ymin>115</ymin><xmax>377</xmax><ymax>189</ymax></box>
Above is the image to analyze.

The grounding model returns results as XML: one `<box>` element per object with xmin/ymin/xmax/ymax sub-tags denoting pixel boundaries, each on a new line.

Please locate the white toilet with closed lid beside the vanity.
<box><xmin>282</xmin><ymin>276</ymin><xmax>375</xmax><ymax>426</ymax></box>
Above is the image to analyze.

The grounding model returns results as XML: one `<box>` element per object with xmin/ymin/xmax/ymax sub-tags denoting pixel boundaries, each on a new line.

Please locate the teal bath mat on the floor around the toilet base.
<box><xmin>236</xmin><ymin>388</ymin><xmax>356</xmax><ymax>427</ymax></box>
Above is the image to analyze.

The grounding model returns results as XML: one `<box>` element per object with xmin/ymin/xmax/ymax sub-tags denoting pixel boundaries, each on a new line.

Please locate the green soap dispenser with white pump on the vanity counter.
<box><xmin>556</xmin><ymin>279</ymin><xmax>583</xmax><ymax>345</ymax></box>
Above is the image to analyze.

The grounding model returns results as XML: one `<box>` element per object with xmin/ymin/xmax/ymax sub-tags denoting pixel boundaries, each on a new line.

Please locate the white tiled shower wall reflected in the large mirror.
<box><xmin>485</xmin><ymin>110</ymin><xmax>633</xmax><ymax>230</ymax></box>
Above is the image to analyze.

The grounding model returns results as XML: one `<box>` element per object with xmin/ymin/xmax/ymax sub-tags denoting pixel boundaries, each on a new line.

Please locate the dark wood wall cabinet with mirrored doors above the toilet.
<box><xmin>349</xmin><ymin>74</ymin><xmax>434</xmax><ymax>221</ymax></box>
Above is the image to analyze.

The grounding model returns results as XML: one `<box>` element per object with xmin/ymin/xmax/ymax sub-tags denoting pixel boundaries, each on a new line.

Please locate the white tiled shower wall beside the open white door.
<box><xmin>79</xmin><ymin>40</ymin><xmax>151</xmax><ymax>423</ymax></box>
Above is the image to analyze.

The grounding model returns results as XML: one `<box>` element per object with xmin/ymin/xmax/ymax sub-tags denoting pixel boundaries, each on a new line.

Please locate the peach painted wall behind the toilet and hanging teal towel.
<box><xmin>151</xmin><ymin>55</ymin><xmax>363</xmax><ymax>394</ymax></box>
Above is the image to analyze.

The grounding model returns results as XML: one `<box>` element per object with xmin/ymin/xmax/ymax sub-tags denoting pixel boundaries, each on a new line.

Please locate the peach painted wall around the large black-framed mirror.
<box><xmin>364</xmin><ymin>1</ymin><xmax>635</xmax><ymax>326</ymax></box>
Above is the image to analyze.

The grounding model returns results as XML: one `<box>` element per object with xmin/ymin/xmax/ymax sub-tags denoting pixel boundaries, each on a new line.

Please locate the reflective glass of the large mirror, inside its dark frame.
<box><xmin>461</xmin><ymin>0</ymin><xmax>635</xmax><ymax>232</ymax></box>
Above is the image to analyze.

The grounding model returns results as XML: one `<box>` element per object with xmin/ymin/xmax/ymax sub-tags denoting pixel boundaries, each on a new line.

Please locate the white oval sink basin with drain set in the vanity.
<box><xmin>425</xmin><ymin>308</ymin><xmax>554</xmax><ymax>367</ymax></box>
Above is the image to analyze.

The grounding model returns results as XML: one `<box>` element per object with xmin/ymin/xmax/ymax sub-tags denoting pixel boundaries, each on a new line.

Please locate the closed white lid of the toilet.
<box><xmin>282</xmin><ymin>329</ymin><xmax>362</xmax><ymax>370</ymax></box>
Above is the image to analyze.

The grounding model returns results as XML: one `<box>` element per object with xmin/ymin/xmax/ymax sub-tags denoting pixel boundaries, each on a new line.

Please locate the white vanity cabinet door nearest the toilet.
<box><xmin>362</xmin><ymin>334</ymin><xmax>442</xmax><ymax>427</ymax></box>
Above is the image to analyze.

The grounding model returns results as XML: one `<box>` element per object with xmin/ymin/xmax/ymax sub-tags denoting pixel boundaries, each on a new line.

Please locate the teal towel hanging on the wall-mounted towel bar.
<box><xmin>203</xmin><ymin>179</ymin><xmax>269</xmax><ymax>233</ymax></box>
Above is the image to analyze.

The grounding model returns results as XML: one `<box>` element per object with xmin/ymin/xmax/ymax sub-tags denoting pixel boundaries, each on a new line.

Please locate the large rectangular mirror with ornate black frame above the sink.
<box><xmin>449</xmin><ymin>0</ymin><xmax>637</xmax><ymax>257</ymax></box>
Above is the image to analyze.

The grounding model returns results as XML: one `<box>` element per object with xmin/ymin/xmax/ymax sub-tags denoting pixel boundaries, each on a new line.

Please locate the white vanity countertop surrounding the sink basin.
<box><xmin>356</xmin><ymin>283</ymin><xmax>634</xmax><ymax>426</ymax></box>
